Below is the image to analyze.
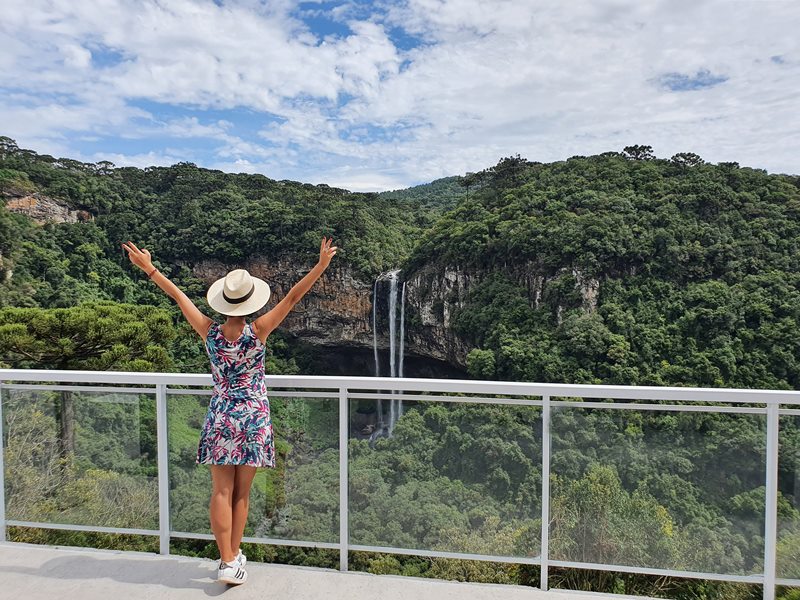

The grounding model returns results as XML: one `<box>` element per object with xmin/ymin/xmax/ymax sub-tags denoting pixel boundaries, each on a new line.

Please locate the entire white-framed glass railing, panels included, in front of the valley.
<box><xmin>0</xmin><ymin>369</ymin><xmax>800</xmax><ymax>600</ymax></box>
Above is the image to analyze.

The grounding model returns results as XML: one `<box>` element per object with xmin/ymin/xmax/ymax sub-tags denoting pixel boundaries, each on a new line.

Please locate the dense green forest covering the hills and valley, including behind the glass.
<box><xmin>0</xmin><ymin>138</ymin><xmax>800</xmax><ymax>600</ymax></box>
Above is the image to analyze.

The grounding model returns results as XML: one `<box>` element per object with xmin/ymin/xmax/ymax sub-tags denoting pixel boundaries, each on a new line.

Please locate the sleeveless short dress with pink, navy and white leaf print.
<box><xmin>195</xmin><ymin>323</ymin><xmax>275</xmax><ymax>467</ymax></box>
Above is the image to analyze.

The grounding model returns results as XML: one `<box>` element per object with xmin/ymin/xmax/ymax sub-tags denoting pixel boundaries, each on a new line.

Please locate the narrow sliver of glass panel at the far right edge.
<box><xmin>777</xmin><ymin>415</ymin><xmax>800</xmax><ymax>580</ymax></box>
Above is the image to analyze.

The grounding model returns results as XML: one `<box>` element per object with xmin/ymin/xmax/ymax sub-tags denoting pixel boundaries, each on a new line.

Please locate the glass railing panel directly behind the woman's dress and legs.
<box><xmin>167</xmin><ymin>394</ymin><xmax>339</xmax><ymax>542</ymax></box>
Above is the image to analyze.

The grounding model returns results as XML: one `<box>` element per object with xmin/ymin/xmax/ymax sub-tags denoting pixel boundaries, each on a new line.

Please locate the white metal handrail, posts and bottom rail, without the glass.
<box><xmin>0</xmin><ymin>369</ymin><xmax>800</xmax><ymax>600</ymax></box>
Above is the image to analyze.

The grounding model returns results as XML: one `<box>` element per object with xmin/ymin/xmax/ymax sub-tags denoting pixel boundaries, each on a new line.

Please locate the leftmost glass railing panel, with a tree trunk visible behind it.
<box><xmin>2</xmin><ymin>388</ymin><xmax>158</xmax><ymax>529</ymax></box>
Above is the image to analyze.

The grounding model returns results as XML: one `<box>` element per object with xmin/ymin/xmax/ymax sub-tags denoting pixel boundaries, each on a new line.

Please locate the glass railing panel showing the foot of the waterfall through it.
<box><xmin>349</xmin><ymin>395</ymin><xmax>542</xmax><ymax>557</ymax></box>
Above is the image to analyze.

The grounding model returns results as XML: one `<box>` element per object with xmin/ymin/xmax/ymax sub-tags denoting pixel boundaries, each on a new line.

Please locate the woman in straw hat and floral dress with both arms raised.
<box><xmin>122</xmin><ymin>237</ymin><xmax>337</xmax><ymax>585</ymax></box>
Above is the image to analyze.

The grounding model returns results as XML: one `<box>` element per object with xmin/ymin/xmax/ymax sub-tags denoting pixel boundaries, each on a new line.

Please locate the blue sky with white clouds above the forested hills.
<box><xmin>0</xmin><ymin>0</ymin><xmax>800</xmax><ymax>191</ymax></box>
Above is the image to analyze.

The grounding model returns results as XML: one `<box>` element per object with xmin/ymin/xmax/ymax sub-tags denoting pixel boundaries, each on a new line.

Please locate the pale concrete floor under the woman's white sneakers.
<box><xmin>0</xmin><ymin>542</ymin><xmax>664</xmax><ymax>600</ymax></box>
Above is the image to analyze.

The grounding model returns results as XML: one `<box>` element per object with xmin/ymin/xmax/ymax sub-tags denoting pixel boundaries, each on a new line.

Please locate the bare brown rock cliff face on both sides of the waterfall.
<box><xmin>186</xmin><ymin>257</ymin><xmax>599</xmax><ymax>374</ymax></box>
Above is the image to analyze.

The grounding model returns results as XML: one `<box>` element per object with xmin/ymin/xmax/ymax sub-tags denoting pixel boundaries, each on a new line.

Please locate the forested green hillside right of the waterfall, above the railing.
<box><xmin>408</xmin><ymin>147</ymin><xmax>800</xmax><ymax>389</ymax></box>
